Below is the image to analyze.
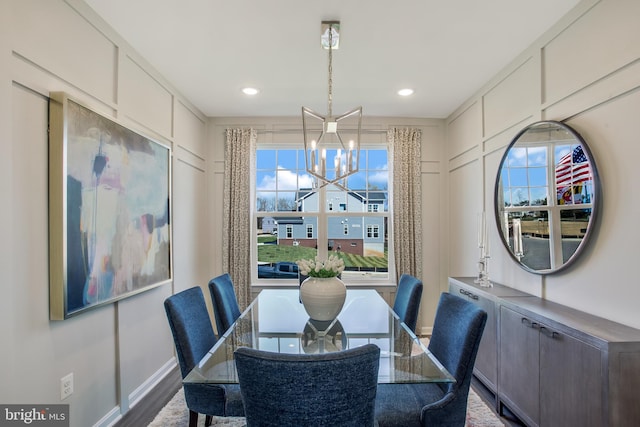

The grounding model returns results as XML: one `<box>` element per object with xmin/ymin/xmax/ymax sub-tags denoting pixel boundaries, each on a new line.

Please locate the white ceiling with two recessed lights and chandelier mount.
<box><xmin>85</xmin><ymin>0</ymin><xmax>579</xmax><ymax>118</ymax></box>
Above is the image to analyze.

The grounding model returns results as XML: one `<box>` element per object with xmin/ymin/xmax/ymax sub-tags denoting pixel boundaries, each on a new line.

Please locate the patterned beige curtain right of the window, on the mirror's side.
<box><xmin>387</xmin><ymin>128</ymin><xmax>422</xmax><ymax>279</ymax></box>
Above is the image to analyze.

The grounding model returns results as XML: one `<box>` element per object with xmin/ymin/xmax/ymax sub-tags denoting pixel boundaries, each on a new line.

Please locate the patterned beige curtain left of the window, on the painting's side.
<box><xmin>222</xmin><ymin>129</ymin><xmax>257</xmax><ymax>310</ymax></box>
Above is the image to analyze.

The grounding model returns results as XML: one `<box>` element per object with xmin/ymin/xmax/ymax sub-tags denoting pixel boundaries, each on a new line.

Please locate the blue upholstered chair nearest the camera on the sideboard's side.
<box><xmin>376</xmin><ymin>293</ymin><xmax>487</xmax><ymax>427</ymax></box>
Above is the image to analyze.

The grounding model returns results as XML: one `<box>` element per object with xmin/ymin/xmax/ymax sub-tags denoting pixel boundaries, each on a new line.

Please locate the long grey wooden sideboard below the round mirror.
<box><xmin>449</xmin><ymin>277</ymin><xmax>640</xmax><ymax>427</ymax></box>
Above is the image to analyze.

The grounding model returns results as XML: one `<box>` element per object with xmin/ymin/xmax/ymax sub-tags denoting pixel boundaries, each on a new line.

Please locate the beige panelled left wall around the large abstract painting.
<box><xmin>0</xmin><ymin>0</ymin><xmax>211</xmax><ymax>426</ymax></box>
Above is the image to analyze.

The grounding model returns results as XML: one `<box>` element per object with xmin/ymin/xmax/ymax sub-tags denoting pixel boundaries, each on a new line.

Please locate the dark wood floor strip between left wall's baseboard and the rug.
<box><xmin>113</xmin><ymin>365</ymin><xmax>182</xmax><ymax>427</ymax></box>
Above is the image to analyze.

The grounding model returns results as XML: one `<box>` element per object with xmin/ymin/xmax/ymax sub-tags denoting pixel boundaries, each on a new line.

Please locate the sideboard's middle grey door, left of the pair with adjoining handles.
<box><xmin>498</xmin><ymin>306</ymin><xmax>540</xmax><ymax>425</ymax></box>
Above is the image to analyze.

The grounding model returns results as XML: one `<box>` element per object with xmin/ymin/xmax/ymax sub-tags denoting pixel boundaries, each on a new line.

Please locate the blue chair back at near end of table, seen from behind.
<box><xmin>235</xmin><ymin>344</ymin><xmax>380</xmax><ymax>427</ymax></box>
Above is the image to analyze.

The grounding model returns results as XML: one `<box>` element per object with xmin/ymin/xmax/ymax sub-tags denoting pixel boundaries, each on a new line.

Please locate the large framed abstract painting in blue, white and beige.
<box><xmin>49</xmin><ymin>92</ymin><xmax>171</xmax><ymax>320</ymax></box>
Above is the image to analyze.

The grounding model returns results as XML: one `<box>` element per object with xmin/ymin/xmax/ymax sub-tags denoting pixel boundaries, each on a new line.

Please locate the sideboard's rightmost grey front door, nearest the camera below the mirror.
<box><xmin>540</xmin><ymin>325</ymin><xmax>605</xmax><ymax>427</ymax></box>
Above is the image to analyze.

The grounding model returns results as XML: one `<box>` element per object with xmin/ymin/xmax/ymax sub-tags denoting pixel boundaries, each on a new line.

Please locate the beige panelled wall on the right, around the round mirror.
<box><xmin>447</xmin><ymin>0</ymin><xmax>640</xmax><ymax>328</ymax></box>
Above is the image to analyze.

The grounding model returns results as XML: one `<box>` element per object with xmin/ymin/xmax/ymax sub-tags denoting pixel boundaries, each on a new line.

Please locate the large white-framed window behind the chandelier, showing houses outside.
<box><xmin>252</xmin><ymin>145</ymin><xmax>392</xmax><ymax>284</ymax></box>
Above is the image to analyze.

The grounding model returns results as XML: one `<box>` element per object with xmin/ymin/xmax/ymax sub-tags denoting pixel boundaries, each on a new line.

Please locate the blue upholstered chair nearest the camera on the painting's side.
<box><xmin>164</xmin><ymin>286</ymin><xmax>244</xmax><ymax>427</ymax></box>
